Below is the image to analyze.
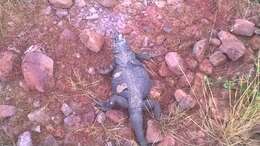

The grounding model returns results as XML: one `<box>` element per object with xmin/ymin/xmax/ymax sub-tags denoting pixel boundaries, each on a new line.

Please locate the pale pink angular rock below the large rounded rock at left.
<box><xmin>27</xmin><ymin>107</ymin><xmax>50</xmax><ymax>124</ymax></box>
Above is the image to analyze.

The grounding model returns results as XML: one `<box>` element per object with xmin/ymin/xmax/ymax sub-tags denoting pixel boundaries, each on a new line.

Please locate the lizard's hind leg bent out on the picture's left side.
<box><xmin>97</xmin><ymin>95</ymin><xmax>128</xmax><ymax>111</ymax></box>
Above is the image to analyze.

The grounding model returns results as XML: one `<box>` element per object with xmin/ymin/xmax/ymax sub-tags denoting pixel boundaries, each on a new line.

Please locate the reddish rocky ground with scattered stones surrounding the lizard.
<box><xmin>0</xmin><ymin>0</ymin><xmax>260</xmax><ymax>146</ymax></box>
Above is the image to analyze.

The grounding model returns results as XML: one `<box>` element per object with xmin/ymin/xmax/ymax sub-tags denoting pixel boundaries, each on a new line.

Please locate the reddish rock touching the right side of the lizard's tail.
<box><xmin>146</xmin><ymin>120</ymin><xmax>163</xmax><ymax>144</ymax></box>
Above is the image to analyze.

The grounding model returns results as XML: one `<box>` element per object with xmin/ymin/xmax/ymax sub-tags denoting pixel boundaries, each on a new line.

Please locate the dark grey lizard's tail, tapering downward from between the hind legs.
<box><xmin>129</xmin><ymin>108</ymin><xmax>148</xmax><ymax>146</ymax></box>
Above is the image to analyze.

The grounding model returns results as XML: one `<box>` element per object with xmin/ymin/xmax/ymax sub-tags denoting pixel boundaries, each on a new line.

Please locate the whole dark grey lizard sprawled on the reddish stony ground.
<box><xmin>98</xmin><ymin>33</ymin><xmax>161</xmax><ymax>146</ymax></box>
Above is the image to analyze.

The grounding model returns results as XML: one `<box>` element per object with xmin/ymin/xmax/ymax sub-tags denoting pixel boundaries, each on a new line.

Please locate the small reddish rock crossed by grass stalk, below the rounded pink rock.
<box><xmin>177</xmin><ymin>71</ymin><xmax>194</xmax><ymax>88</ymax></box>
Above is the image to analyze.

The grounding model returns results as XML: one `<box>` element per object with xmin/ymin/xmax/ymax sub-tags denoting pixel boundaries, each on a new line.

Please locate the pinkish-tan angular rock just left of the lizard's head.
<box><xmin>79</xmin><ymin>29</ymin><xmax>105</xmax><ymax>53</ymax></box>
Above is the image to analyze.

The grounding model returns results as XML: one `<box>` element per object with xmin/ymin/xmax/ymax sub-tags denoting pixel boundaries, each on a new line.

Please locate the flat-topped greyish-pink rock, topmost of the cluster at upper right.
<box><xmin>231</xmin><ymin>19</ymin><xmax>255</xmax><ymax>36</ymax></box>
